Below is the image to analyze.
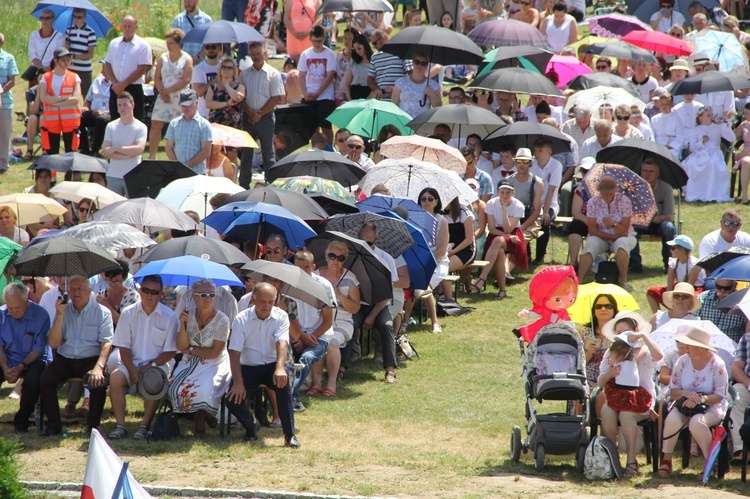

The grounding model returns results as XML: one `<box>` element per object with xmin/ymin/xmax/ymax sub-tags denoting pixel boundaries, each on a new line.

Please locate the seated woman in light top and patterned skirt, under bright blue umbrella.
<box><xmin>169</xmin><ymin>279</ymin><xmax>231</xmax><ymax>434</ymax></box>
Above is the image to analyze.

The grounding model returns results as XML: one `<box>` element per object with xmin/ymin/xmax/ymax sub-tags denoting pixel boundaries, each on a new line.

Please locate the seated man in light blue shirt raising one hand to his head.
<box><xmin>40</xmin><ymin>276</ymin><xmax>113</xmax><ymax>436</ymax></box>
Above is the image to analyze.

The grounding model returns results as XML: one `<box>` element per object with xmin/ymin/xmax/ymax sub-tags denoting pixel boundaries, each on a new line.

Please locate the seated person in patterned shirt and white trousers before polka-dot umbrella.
<box><xmin>578</xmin><ymin>176</ymin><xmax>637</xmax><ymax>291</ymax></box>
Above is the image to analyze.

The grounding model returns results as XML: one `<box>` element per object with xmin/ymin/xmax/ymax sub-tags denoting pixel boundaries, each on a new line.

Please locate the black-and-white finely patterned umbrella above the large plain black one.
<box><xmin>325</xmin><ymin>212</ymin><xmax>414</xmax><ymax>258</ymax></box>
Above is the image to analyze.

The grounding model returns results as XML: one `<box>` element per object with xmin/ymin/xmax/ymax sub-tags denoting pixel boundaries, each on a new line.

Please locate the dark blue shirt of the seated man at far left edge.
<box><xmin>0</xmin><ymin>302</ymin><xmax>52</xmax><ymax>367</ymax></box>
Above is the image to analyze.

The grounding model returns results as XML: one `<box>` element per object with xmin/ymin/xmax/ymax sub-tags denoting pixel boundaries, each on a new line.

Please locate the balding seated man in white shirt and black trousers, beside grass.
<box><xmin>227</xmin><ymin>282</ymin><xmax>300</xmax><ymax>449</ymax></box>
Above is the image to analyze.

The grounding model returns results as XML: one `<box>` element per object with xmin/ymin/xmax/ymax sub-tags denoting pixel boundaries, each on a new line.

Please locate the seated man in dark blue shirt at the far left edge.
<box><xmin>0</xmin><ymin>283</ymin><xmax>52</xmax><ymax>433</ymax></box>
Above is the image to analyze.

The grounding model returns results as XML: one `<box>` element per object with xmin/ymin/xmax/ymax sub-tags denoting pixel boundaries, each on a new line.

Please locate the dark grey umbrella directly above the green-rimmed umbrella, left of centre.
<box><xmin>266</xmin><ymin>151</ymin><xmax>366</xmax><ymax>187</ymax></box>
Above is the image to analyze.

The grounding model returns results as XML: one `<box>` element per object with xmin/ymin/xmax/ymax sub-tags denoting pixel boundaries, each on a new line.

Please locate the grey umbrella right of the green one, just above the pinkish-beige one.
<box><xmin>407</xmin><ymin>104</ymin><xmax>505</xmax><ymax>138</ymax></box>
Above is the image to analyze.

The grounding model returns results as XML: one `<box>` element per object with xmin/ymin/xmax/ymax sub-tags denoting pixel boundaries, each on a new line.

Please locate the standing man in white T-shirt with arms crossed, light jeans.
<box><xmin>102</xmin><ymin>92</ymin><xmax>148</xmax><ymax>197</ymax></box>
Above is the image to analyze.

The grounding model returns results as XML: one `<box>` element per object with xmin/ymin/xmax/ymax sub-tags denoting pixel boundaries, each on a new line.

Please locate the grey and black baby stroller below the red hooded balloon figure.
<box><xmin>510</xmin><ymin>323</ymin><xmax>589</xmax><ymax>471</ymax></box>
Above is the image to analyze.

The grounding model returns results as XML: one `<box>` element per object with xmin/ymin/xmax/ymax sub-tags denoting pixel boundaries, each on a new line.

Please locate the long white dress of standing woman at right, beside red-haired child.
<box><xmin>682</xmin><ymin>123</ymin><xmax>735</xmax><ymax>202</ymax></box>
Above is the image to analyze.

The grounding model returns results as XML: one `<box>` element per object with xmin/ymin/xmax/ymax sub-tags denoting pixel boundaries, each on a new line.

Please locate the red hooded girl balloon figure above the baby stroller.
<box><xmin>518</xmin><ymin>265</ymin><xmax>578</xmax><ymax>343</ymax></box>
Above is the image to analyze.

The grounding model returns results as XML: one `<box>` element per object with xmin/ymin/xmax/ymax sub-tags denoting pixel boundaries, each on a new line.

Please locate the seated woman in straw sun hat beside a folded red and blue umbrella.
<box><xmin>658</xmin><ymin>327</ymin><xmax>729</xmax><ymax>477</ymax></box>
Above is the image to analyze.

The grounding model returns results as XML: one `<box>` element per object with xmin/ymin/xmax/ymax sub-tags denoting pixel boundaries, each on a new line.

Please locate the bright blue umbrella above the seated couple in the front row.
<box><xmin>133</xmin><ymin>255</ymin><xmax>244</xmax><ymax>286</ymax></box>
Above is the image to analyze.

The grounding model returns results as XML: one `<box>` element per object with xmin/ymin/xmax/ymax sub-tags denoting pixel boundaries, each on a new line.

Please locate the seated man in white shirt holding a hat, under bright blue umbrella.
<box><xmin>108</xmin><ymin>275</ymin><xmax>178</xmax><ymax>440</ymax></box>
